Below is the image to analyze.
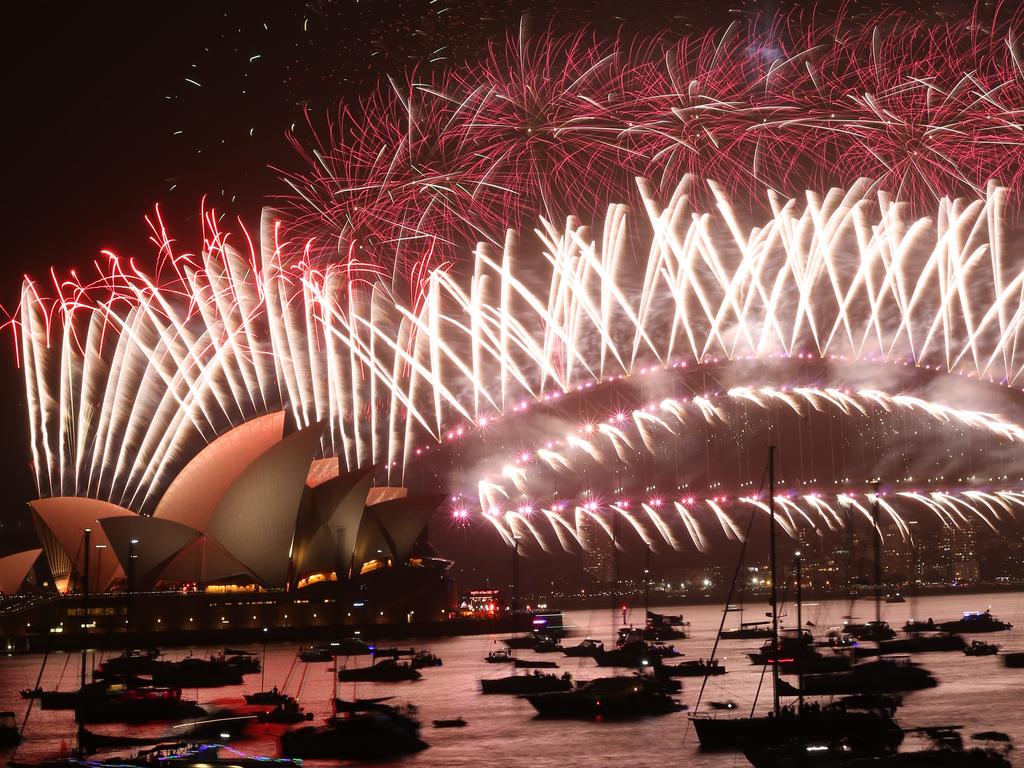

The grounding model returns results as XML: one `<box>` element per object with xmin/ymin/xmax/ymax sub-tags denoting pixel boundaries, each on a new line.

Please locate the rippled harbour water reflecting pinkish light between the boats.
<box><xmin>0</xmin><ymin>593</ymin><xmax>1024</xmax><ymax>768</ymax></box>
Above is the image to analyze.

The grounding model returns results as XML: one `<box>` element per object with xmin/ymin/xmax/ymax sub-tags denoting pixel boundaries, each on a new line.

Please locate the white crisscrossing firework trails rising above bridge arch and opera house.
<box><xmin>16</xmin><ymin>182</ymin><xmax>1024</xmax><ymax>514</ymax></box>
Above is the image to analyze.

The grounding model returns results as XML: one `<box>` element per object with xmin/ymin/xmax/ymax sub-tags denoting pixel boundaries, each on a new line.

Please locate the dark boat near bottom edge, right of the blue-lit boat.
<box><xmin>281</xmin><ymin>710</ymin><xmax>427</xmax><ymax>761</ymax></box>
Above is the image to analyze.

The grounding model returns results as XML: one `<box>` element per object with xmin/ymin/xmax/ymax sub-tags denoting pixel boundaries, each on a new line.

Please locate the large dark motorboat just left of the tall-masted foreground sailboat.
<box><xmin>526</xmin><ymin>677</ymin><xmax>682</xmax><ymax>720</ymax></box>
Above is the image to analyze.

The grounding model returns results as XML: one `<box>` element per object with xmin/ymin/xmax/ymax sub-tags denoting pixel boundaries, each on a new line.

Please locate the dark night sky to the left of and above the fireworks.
<box><xmin>0</xmin><ymin>0</ymin><xmax>987</xmax><ymax>581</ymax></box>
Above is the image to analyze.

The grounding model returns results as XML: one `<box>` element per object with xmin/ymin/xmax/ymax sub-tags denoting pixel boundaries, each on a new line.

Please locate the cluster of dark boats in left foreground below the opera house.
<box><xmin>0</xmin><ymin>638</ymin><xmax>446</xmax><ymax>768</ymax></box>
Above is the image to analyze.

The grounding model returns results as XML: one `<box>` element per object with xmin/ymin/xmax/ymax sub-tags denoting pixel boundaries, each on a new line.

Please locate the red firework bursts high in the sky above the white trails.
<box><xmin>284</xmin><ymin>13</ymin><xmax>1024</xmax><ymax>276</ymax></box>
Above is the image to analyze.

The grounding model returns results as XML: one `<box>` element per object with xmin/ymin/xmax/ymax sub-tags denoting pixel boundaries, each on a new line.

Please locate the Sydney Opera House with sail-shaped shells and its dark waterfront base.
<box><xmin>0</xmin><ymin>411</ymin><xmax>453</xmax><ymax>644</ymax></box>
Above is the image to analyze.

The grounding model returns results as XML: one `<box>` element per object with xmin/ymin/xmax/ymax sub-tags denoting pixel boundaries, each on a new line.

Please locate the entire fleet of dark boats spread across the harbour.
<box><xmin>0</xmin><ymin>456</ymin><xmax>1024</xmax><ymax>768</ymax></box>
